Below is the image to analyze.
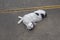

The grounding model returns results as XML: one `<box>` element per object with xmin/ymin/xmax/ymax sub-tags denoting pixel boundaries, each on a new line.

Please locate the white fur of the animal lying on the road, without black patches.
<box><xmin>18</xmin><ymin>10</ymin><xmax>46</xmax><ymax>29</ymax></box>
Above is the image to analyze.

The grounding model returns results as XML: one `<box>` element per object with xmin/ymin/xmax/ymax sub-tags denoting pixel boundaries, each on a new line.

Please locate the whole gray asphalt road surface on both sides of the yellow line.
<box><xmin>0</xmin><ymin>0</ymin><xmax>60</xmax><ymax>40</ymax></box>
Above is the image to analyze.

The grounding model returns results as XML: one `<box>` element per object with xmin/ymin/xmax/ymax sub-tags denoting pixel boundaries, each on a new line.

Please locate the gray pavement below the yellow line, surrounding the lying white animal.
<box><xmin>0</xmin><ymin>9</ymin><xmax>60</xmax><ymax>40</ymax></box>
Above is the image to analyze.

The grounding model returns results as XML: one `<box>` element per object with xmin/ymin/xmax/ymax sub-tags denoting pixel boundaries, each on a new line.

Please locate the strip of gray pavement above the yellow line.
<box><xmin>0</xmin><ymin>0</ymin><xmax>60</xmax><ymax>9</ymax></box>
